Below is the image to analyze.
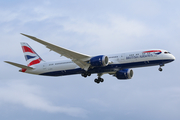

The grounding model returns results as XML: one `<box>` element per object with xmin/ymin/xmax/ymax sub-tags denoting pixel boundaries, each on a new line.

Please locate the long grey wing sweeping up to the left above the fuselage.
<box><xmin>21</xmin><ymin>33</ymin><xmax>91</xmax><ymax>71</ymax></box>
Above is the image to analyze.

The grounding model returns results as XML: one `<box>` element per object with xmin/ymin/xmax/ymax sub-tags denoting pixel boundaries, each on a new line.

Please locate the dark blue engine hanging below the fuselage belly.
<box><xmin>115</xmin><ymin>69</ymin><xmax>133</xmax><ymax>79</ymax></box>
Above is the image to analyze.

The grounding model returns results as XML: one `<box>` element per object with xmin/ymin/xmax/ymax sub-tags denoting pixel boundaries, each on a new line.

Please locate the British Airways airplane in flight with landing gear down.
<box><xmin>4</xmin><ymin>33</ymin><xmax>175</xmax><ymax>84</ymax></box>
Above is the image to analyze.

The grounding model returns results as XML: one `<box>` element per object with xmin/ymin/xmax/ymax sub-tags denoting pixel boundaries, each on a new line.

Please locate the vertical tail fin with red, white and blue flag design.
<box><xmin>21</xmin><ymin>42</ymin><xmax>43</xmax><ymax>66</ymax></box>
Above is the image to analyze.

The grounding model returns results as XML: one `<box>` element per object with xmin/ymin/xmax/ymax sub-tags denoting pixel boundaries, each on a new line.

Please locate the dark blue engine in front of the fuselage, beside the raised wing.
<box><xmin>90</xmin><ymin>55</ymin><xmax>109</xmax><ymax>67</ymax></box>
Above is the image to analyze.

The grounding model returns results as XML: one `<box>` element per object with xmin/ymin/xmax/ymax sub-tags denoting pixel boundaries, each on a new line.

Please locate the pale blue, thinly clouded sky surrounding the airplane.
<box><xmin>0</xmin><ymin>0</ymin><xmax>180</xmax><ymax>120</ymax></box>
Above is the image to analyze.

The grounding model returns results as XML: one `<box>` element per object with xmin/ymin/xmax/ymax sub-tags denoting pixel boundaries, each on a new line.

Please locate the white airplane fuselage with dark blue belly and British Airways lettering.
<box><xmin>25</xmin><ymin>50</ymin><xmax>175</xmax><ymax>76</ymax></box>
